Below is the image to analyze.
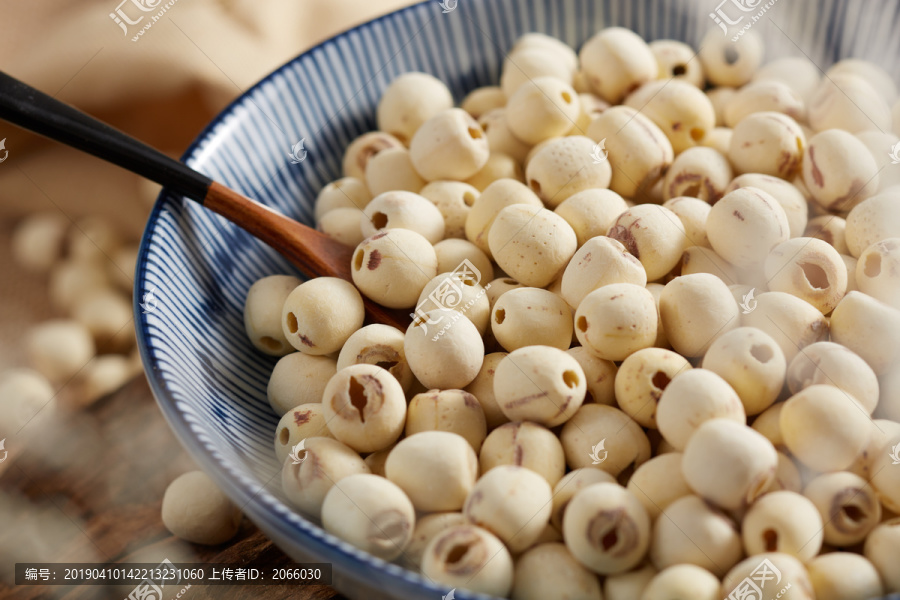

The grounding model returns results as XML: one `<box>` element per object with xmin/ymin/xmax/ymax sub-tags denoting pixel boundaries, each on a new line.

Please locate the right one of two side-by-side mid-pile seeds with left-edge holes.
<box><xmin>575</xmin><ymin>283</ymin><xmax>656</xmax><ymax>361</ymax></box>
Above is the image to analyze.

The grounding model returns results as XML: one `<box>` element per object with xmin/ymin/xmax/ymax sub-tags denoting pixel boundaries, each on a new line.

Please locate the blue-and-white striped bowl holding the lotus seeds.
<box><xmin>135</xmin><ymin>0</ymin><xmax>900</xmax><ymax>600</ymax></box>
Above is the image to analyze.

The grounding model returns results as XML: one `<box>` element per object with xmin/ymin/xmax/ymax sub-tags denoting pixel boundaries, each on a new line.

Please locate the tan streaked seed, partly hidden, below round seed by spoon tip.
<box><xmin>406</xmin><ymin>390</ymin><xmax>487</xmax><ymax>453</ymax></box>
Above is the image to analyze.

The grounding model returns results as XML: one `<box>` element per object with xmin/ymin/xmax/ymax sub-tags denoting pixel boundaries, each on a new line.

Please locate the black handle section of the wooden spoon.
<box><xmin>0</xmin><ymin>71</ymin><xmax>212</xmax><ymax>204</ymax></box>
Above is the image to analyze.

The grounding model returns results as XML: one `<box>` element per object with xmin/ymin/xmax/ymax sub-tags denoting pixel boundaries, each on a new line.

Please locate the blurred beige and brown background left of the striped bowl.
<box><xmin>0</xmin><ymin>0</ymin><xmax>412</xmax><ymax>598</ymax></box>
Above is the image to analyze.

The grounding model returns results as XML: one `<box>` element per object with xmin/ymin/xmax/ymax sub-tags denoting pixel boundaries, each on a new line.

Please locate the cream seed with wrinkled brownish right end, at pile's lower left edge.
<box><xmin>322</xmin><ymin>474</ymin><xmax>416</xmax><ymax>560</ymax></box>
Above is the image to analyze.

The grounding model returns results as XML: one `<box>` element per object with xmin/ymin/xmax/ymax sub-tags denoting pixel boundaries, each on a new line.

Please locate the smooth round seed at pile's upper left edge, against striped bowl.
<box><xmin>373</xmin><ymin>73</ymin><xmax>453</xmax><ymax>144</ymax></box>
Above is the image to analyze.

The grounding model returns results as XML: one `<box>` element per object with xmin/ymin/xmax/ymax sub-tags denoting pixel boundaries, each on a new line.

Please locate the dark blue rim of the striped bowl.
<box><xmin>132</xmin><ymin>0</ymin><xmax>474</xmax><ymax>598</ymax></box>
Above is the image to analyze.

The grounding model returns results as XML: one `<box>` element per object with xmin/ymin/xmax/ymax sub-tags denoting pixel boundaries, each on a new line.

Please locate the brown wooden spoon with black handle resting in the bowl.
<box><xmin>0</xmin><ymin>71</ymin><xmax>411</xmax><ymax>331</ymax></box>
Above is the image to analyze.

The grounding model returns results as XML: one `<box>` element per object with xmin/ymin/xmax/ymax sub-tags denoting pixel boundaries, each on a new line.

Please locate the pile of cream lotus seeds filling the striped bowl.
<box><xmin>244</xmin><ymin>28</ymin><xmax>900</xmax><ymax>600</ymax></box>
